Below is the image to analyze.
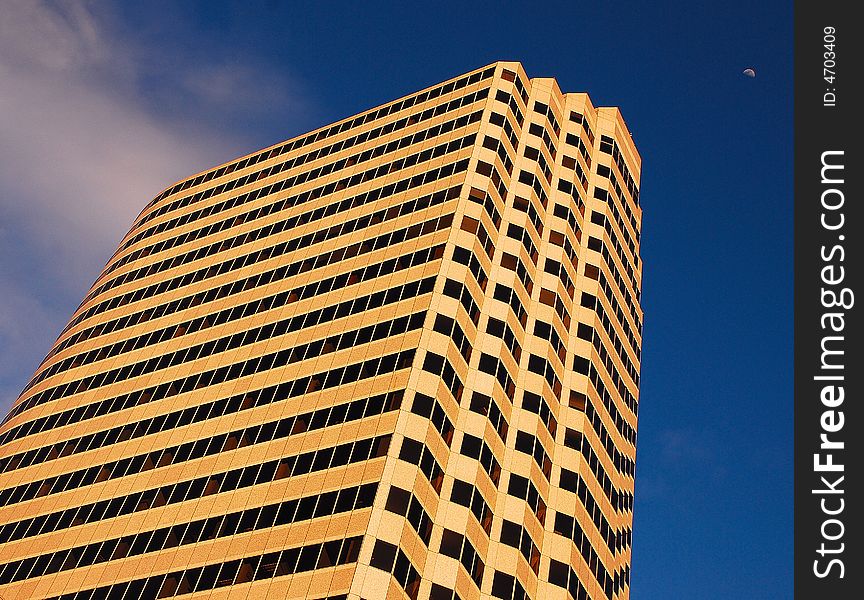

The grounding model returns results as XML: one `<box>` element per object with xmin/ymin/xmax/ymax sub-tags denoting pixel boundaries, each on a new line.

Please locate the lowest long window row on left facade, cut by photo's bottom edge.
<box><xmin>50</xmin><ymin>536</ymin><xmax>363</xmax><ymax>600</ymax></box>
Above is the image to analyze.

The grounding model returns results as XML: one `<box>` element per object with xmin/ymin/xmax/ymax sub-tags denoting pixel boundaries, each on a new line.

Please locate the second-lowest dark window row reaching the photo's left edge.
<box><xmin>0</xmin><ymin>435</ymin><xmax>390</xmax><ymax>543</ymax></box>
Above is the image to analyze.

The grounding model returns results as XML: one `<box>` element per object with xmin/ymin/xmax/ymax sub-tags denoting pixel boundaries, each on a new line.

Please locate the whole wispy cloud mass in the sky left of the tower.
<box><xmin>0</xmin><ymin>0</ymin><xmax>310</xmax><ymax>412</ymax></box>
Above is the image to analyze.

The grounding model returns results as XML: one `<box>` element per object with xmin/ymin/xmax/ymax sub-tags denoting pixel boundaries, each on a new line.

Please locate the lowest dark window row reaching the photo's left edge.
<box><xmin>0</xmin><ymin>483</ymin><xmax>378</xmax><ymax>585</ymax></box>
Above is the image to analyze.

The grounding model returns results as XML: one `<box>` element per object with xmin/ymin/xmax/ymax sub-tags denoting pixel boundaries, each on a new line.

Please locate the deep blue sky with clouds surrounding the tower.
<box><xmin>0</xmin><ymin>0</ymin><xmax>792</xmax><ymax>600</ymax></box>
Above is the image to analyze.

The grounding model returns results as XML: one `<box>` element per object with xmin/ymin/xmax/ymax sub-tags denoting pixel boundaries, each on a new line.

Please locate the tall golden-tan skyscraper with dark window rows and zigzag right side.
<box><xmin>0</xmin><ymin>62</ymin><xmax>642</xmax><ymax>600</ymax></box>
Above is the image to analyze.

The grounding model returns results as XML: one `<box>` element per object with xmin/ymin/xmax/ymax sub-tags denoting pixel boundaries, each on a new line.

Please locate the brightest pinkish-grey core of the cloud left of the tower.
<box><xmin>0</xmin><ymin>61</ymin><xmax>230</xmax><ymax>284</ymax></box>
